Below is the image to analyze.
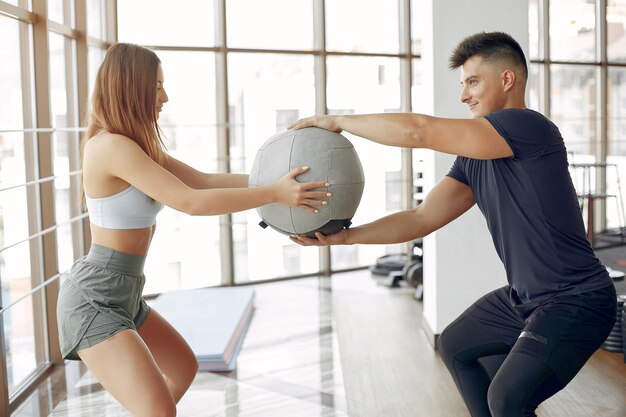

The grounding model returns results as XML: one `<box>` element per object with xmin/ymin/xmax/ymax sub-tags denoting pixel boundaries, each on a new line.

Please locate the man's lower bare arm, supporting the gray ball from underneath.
<box><xmin>291</xmin><ymin>177</ymin><xmax>474</xmax><ymax>246</ymax></box>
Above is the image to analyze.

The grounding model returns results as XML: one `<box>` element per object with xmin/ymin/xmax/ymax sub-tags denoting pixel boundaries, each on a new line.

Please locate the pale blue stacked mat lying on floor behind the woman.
<box><xmin>152</xmin><ymin>287</ymin><xmax>254</xmax><ymax>372</ymax></box>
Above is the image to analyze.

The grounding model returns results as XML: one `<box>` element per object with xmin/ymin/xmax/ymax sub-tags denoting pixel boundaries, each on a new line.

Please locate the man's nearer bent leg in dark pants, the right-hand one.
<box><xmin>488</xmin><ymin>287</ymin><xmax>615</xmax><ymax>417</ymax></box>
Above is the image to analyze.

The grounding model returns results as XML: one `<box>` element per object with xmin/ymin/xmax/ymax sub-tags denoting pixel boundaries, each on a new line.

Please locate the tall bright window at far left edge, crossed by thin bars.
<box><xmin>0</xmin><ymin>16</ymin><xmax>41</xmax><ymax>394</ymax></box>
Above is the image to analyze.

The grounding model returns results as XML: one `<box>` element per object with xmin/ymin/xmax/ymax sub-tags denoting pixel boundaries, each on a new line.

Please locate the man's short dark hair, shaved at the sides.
<box><xmin>450</xmin><ymin>32</ymin><xmax>528</xmax><ymax>77</ymax></box>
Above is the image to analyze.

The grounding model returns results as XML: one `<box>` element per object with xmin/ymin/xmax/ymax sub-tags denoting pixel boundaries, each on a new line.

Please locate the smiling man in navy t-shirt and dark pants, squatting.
<box><xmin>291</xmin><ymin>32</ymin><xmax>616</xmax><ymax>417</ymax></box>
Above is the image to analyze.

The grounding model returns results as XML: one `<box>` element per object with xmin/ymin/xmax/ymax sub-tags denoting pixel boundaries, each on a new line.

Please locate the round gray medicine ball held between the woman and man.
<box><xmin>248</xmin><ymin>127</ymin><xmax>365</xmax><ymax>237</ymax></box>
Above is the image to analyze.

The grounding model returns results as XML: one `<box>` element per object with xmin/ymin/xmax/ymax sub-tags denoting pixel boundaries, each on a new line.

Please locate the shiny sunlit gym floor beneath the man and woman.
<box><xmin>12</xmin><ymin>271</ymin><xmax>626</xmax><ymax>417</ymax></box>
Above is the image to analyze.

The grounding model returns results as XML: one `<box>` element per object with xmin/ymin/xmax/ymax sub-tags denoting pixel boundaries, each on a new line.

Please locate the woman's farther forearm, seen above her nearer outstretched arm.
<box><xmin>164</xmin><ymin>155</ymin><xmax>248</xmax><ymax>190</ymax></box>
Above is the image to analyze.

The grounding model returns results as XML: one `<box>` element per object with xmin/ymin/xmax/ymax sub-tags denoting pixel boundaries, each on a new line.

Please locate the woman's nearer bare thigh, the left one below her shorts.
<box><xmin>78</xmin><ymin>329</ymin><xmax>176</xmax><ymax>417</ymax></box>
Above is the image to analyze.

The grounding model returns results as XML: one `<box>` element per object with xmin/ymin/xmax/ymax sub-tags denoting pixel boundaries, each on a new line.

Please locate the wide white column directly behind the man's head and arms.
<box><xmin>417</xmin><ymin>0</ymin><xmax>528</xmax><ymax>342</ymax></box>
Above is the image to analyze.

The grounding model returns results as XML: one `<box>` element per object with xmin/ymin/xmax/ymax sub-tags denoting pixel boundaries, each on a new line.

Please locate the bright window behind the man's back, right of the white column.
<box><xmin>529</xmin><ymin>0</ymin><xmax>626</xmax><ymax>239</ymax></box>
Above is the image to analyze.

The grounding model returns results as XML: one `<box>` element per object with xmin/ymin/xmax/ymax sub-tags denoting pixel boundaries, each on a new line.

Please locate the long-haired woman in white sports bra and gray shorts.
<box><xmin>57</xmin><ymin>44</ymin><xmax>329</xmax><ymax>417</ymax></box>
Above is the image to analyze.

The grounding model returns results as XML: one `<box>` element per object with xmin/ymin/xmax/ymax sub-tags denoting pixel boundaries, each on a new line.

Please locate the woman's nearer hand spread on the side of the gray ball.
<box><xmin>274</xmin><ymin>167</ymin><xmax>331</xmax><ymax>213</ymax></box>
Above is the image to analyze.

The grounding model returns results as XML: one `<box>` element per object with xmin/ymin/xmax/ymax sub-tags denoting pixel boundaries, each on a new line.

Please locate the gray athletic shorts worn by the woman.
<box><xmin>57</xmin><ymin>245</ymin><xmax>150</xmax><ymax>360</ymax></box>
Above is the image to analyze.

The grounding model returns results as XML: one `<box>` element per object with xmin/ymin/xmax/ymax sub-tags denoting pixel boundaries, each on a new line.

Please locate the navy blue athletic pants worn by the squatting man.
<box><xmin>439</xmin><ymin>285</ymin><xmax>617</xmax><ymax>417</ymax></box>
